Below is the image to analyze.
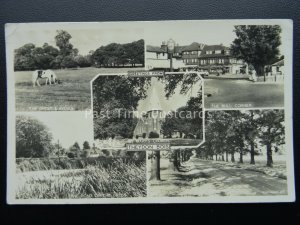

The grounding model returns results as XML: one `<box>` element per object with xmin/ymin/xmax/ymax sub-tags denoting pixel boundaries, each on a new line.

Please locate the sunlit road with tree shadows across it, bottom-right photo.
<box><xmin>148</xmin><ymin>158</ymin><xmax>287</xmax><ymax>196</ymax></box>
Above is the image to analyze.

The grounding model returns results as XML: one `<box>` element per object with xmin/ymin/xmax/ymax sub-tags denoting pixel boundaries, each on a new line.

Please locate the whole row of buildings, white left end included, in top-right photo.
<box><xmin>146</xmin><ymin>42</ymin><xmax>246</xmax><ymax>74</ymax></box>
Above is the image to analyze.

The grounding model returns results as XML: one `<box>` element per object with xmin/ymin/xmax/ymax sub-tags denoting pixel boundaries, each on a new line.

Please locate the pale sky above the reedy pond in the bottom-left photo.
<box><xmin>19</xmin><ymin>111</ymin><xmax>94</xmax><ymax>148</ymax></box>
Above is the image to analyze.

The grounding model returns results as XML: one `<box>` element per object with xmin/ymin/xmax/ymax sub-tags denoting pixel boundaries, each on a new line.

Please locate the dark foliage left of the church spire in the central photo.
<box><xmin>93</xmin><ymin>76</ymin><xmax>150</xmax><ymax>139</ymax></box>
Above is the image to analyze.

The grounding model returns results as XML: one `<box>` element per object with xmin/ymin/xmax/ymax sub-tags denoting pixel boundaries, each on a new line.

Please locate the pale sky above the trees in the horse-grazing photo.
<box><xmin>10</xmin><ymin>23</ymin><xmax>144</xmax><ymax>55</ymax></box>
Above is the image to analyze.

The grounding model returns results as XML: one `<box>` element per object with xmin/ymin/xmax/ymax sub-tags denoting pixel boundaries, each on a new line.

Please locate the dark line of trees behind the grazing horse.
<box><xmin>14</xmin><ymin>30</ymin><xmax>144</xmax><ymax>71</ymax></box>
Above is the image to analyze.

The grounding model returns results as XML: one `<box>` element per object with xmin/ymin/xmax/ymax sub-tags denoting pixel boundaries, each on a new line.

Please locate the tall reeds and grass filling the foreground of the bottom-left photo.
<box><xmin>16</xmin><ymin>159</ymin><xmax>146</xmax><ymax>199</ymax></box>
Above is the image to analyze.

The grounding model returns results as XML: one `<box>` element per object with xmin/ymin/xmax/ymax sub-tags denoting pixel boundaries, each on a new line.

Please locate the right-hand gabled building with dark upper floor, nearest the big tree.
<box><xmin>199</xmin><ymin>45</ymin><xmax>245</xmax><ymax>74</ymax></box>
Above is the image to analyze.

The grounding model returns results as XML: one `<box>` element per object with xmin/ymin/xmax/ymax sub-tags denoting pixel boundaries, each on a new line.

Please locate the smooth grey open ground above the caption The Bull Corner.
<box><xmin>204</xmin><ymin>79</ymin><xmax>284</xmax><ymax>108</ymax></box>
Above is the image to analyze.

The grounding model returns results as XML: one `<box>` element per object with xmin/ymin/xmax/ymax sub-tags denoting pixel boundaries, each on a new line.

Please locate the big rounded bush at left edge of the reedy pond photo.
<box><xmin>16</xmin><ymin>115</ymin><xmax>53</xmax><ymax>158</ymax></box>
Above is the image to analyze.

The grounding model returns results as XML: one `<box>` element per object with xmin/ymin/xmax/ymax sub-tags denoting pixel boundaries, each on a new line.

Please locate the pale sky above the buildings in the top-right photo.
<box><xmin>145</xmin><ymin>20</ymin><xmax>286</xmax><ymax>54</ymax></box>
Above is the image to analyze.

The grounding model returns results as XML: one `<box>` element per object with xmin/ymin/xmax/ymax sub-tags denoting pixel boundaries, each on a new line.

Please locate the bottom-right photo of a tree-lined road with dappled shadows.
<box><xmin>147</xmin><ymin>109</ymin><xmax>291</xmax><ymax>199</ymax></box>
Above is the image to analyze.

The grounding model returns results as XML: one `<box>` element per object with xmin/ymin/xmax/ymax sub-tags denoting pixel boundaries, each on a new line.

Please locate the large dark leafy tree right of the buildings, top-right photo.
<box><xmin>231</xmin><ymin>25</ymin><xmax>281</xmax><ymax>80</ymax></box>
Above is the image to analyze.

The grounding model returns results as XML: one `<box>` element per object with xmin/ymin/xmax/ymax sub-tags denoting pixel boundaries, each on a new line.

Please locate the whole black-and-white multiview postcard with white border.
<box><xmin>5</xmin><ymin>19</ymin><xmax>295</xmax><ymax>204</ymax></box>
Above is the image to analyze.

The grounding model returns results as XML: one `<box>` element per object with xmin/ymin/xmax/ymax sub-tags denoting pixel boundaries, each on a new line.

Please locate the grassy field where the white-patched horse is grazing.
<box><xmin>15</xmin><ymin>67</ymin><xmax>141</xmax><ymax>111</ymax></box>
